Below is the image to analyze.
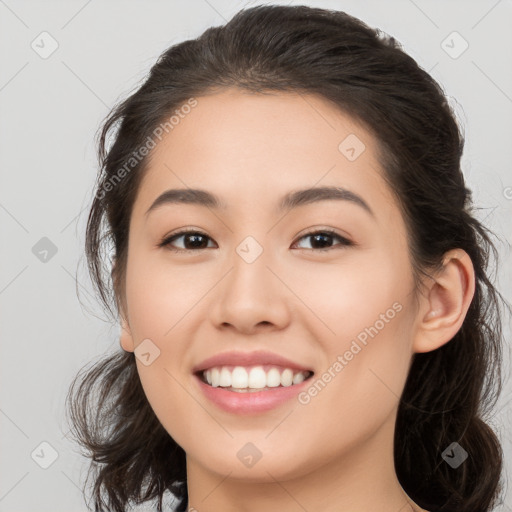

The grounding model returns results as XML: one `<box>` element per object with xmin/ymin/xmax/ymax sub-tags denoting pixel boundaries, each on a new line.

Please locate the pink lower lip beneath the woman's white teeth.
<box><xmin>194</xmin><ymin>375</ymin><xmax>311</xmax><ymax>414</ymax></box>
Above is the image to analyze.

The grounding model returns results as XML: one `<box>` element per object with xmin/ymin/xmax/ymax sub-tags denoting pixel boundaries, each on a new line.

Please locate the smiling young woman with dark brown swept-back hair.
<box><xmin>68</xmin><ymin>6</ymin><xmax>508</xmax><ymax>512</ymax></box>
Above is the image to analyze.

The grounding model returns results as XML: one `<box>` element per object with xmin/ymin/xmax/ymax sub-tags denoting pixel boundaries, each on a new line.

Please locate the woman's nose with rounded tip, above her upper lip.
<box><xmin>211</xmin><ymin>247</ymin><xmax>293</xmax><ymax>334</ymax></box>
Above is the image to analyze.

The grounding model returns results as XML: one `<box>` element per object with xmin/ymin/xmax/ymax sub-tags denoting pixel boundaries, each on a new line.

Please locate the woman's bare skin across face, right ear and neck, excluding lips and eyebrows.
<box><xmin>120</xmin><ymin>89</ymin><xmax>474</xmax><ymax>512</ymax></box>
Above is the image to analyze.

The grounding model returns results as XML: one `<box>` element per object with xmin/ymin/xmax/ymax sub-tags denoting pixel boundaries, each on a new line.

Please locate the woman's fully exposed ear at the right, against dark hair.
<box><xmin>413</xmin><ymin>249</ymin><xmax>475</xmax><ymax>352</ymax></box>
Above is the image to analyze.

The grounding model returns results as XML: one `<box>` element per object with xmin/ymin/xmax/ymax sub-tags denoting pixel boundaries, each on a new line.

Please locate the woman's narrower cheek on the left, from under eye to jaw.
<box><xmin>121</xmin><ymin>251</ymin><xmax>211</xmax><ymax>430</ymax></box>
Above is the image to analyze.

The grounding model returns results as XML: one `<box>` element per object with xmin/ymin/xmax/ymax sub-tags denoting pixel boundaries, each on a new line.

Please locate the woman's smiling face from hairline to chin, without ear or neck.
<box><xmin>121</xmin><ymin>90</ymin><xmax>416</xmax><ymax>481</ymax></box>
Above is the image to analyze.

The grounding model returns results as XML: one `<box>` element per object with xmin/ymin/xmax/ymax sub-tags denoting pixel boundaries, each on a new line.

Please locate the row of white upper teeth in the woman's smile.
<box><xmin>203</xmin><ymin>366</ymin><xmax>311</xmax><ymax>390</ymax></box>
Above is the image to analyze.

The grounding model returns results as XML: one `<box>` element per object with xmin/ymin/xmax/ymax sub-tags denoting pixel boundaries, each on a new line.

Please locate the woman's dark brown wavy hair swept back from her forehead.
<box><xmin>67</xmin><ymin>5</ymin><xmax>505</xmax><ymax>512</ymax></box>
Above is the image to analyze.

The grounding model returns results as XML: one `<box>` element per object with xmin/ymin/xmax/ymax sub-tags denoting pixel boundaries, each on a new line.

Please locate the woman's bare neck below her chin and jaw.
<box><xmin>183</xmin><ymin>412</ymin><xmax>425</xmax><ymax>512</ymax></box>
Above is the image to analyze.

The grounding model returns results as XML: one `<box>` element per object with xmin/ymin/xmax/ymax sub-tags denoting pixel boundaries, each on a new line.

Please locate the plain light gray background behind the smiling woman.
<box><xmin>0</xmin><ymin>0</ymin><xmax>512</xmax><ymax>512</ymax></box>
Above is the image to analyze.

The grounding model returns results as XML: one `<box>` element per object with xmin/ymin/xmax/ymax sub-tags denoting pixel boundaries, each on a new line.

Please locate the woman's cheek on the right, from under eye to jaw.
<box><xmin>290</xmin><ymin>250</ymin><xmax>414</xmax><ymax>418</ymax></box>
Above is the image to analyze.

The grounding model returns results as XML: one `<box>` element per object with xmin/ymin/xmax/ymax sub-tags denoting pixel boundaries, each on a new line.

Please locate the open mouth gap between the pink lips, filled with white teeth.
<box><xmin>195</xmin><ymin>365</ymin><xmax>314</xmax><ymax>393</ymax></box>
